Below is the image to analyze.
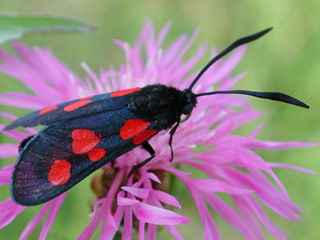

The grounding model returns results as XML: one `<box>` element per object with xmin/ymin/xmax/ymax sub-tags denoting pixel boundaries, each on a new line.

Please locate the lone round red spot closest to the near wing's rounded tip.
<box><xmin>47</xmin><ymin>159</ymin><xmax>71</xmax><ymax>186</ymax></box>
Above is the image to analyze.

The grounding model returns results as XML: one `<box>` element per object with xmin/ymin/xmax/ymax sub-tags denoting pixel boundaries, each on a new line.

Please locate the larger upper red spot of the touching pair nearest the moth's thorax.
<box><xmin>120</xmin><ymin>119</ymin><xmax>151</xmax><ymax>140</ymax></box>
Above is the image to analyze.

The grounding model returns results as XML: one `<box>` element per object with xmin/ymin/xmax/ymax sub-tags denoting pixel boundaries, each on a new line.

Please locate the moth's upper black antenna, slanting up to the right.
<box><xmin>189</xmin><ymin>28</ymin><xmax>272</xmax><ymax>90</ymax></box>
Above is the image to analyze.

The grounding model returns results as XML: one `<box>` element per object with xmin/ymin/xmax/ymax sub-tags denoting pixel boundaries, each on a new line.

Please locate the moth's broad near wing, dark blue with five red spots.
<box><xmin>11</xmin><ymin>107</ymin><xmax>158</xmax><ymax>206</ymax></box>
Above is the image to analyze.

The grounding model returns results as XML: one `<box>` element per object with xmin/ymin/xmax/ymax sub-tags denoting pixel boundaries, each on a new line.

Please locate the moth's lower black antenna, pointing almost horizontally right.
<box><xmin>195</xmin><ymin>90</ymin><xmax>309</xmax><ymax>108</ymax></box>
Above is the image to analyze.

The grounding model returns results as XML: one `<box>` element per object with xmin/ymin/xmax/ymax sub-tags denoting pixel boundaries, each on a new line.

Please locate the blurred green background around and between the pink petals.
<box><xmin>0</xmin><ymin>0</ymin><xmax>320</xmax><ymax>239</ymax></box>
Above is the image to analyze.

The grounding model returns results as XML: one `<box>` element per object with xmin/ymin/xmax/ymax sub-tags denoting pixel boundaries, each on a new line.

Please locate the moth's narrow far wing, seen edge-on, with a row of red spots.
<box><xmin>5</xmin><ymin>88</ymin><xmax>140</xmax><ymax>130</ymax></box>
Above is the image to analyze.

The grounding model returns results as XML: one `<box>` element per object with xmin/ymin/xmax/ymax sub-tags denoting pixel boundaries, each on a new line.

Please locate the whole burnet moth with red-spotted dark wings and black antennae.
<box><xmin>5</xmin><ymin>28</ymin><xmax>309</xmax><ymax>206</ymax></box>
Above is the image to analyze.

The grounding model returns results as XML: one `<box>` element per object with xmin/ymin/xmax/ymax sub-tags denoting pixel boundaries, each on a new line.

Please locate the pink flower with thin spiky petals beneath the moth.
<box><xmin>0</xmin><ymin>23</ymin><xmax>314</xmax><ymax>239</ymax></box>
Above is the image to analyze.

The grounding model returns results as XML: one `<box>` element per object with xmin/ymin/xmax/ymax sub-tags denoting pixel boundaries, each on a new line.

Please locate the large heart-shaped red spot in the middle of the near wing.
<box><xmin>71</xmin><ymin>129</ymin><xmax>100</xmax><ymax>154</ymax></box>
